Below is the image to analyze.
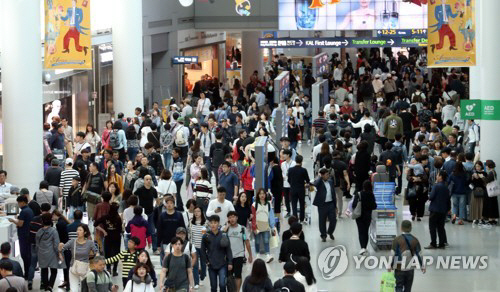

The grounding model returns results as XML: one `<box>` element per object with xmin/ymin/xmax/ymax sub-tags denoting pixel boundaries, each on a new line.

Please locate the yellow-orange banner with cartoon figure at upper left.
<box><xmin>44</xmin><ymin>0</ymin><xmax>92</xmax><ymax>69</ymax></box>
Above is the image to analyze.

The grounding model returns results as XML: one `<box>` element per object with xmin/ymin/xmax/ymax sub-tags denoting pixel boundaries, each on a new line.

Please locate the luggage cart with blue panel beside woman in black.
<box><xmin>370</xmin><ymin>182</ymin><xmax>398</xmax><ymax>250</ymax></box>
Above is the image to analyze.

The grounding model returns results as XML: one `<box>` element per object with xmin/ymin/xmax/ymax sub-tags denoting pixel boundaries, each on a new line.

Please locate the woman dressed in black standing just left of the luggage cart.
<box><xmin>352</xmin><ymin>180</ymin><xmax>377</xmax><ymax>255</ymax></box>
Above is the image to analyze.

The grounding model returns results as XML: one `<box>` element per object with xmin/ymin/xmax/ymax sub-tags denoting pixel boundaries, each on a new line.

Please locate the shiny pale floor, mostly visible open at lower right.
<box><xmin>28</xmin><ymin>144</ymin><xmax>500</xmax><ymax>292</ymax></box>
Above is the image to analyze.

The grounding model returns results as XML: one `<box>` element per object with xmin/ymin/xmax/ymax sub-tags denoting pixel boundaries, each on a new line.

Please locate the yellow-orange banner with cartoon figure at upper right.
<box><xmin>428</xmin><ymin>0</ymin><xmax>476</xmax><ymax>67</ymax></box>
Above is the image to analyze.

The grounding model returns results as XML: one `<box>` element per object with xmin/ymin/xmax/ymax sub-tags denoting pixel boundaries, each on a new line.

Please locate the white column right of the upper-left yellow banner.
<box><xmin>113</xmin><ymin>0</ymin><xmax>144</xmax><ymax>117</ymax></box>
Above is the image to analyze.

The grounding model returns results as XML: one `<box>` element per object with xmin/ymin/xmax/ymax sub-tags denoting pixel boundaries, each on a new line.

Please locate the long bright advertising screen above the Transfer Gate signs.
<box><xmin>278</xmin><ymin>0</ymin><xmax>427</xmax><ymax>30</ymax></box>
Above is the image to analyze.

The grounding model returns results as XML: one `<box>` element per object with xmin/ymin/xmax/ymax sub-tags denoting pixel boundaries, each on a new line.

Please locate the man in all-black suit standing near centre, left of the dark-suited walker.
<box><xmin>288</xmin><ymin>155</ymin><xmax>310</xmax><ymax>222</ymax></box>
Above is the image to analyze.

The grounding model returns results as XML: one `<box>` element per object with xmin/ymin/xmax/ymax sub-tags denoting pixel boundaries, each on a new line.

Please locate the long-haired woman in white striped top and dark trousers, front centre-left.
<box><xmin>190</xmin><ymin>206</ymin><xmax>207</xmax><ymax>288</ymax></box>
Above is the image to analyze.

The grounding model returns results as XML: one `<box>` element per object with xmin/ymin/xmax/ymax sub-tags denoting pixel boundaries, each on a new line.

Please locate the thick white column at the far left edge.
<box><xmin>0</xmin><ymin>0</ymin><xmax>43</xmax><ymax>194</ymax></box>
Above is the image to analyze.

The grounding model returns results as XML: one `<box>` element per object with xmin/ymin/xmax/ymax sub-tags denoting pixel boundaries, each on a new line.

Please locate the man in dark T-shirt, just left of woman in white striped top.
<box><xmin>153</xmin><ymin>196</ymin><xmax>186</xmax><ymax>260</ymax></box>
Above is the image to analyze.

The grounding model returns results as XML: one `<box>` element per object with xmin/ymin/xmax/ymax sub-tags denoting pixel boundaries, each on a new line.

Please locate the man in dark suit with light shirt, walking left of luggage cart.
<box><xmin>313</xmin><ymin>168</ymin><xmax>337</xmax><ymax>242</ymax></box>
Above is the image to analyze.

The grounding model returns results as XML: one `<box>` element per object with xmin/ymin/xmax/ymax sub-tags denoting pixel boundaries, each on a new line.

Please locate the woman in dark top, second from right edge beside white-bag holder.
<box><xmin>470</xmin><ymin>161</ymin><xmax>488</xmax><ymax>225</ymax></box>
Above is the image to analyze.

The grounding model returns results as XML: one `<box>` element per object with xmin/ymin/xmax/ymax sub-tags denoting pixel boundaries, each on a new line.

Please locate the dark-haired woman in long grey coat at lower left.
<box><xmin>35</xmin><ymin>213</ymin><xmax>59</xmax><ymax>291</ymax></box>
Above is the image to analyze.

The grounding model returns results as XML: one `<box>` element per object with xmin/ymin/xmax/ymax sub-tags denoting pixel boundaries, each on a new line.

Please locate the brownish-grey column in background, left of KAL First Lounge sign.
<box><xmin>241</xmin><ymin>31</ymin><xmax>264</xmax><ymax>85</ymax></box>
